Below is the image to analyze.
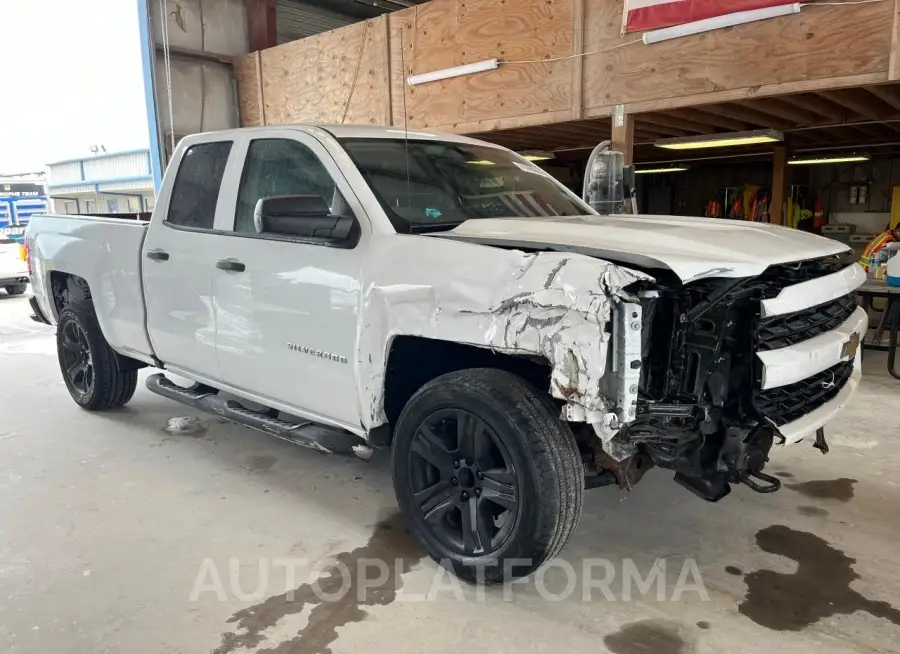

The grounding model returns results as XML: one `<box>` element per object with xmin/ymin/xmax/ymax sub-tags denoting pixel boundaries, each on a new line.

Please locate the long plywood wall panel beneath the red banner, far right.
<box><xmin>584</xmin><ymin>0</ymin><xmax>893</xmax><ymax>114</ymax></box>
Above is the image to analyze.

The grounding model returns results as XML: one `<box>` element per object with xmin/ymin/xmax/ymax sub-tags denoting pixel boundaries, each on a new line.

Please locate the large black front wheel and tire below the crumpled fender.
<box><xmin>391</xmin><ymin>368</ymin><xmax>584</xmax><ymax>584</ymax></box>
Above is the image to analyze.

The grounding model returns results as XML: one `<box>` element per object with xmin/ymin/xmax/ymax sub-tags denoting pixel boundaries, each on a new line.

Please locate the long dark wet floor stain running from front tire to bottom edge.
<box><xmin>212</xmin><ymin>514</ymin><xmax>425</xmax><ymax>654</ymax></box>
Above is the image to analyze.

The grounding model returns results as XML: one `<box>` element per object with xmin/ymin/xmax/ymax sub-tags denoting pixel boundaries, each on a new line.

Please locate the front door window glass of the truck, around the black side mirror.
<box><xmin>234</xmin><ymin>139</ymin><xmax>346</xmax><ymax>234</ymax></box>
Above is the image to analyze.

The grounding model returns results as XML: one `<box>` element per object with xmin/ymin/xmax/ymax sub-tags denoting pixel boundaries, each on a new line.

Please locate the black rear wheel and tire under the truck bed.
<box><xmin>56</xmin><ymin>300</ymin><xmax>137</xmax><ymax>411</ymax></box>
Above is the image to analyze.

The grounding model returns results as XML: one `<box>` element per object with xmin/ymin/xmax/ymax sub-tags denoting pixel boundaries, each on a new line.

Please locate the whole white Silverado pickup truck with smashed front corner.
<box><xmin>27</xmin><ymin>126</ymin><xmax>866</xmax><ymax>582</ymax></box>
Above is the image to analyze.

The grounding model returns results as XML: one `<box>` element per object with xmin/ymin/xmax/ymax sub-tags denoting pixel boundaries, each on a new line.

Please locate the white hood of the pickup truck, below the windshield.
<box><xmin>430</xmin><ymin>215</ymin><xmax>848</xmax><ymax>283</ymax></box>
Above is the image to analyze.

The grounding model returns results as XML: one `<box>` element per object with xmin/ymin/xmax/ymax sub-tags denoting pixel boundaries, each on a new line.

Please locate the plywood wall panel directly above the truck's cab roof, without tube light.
<box><xmin>262</xmin><ymin>17</ymin><xmax>390</xmax><ymax>125</ymax></box>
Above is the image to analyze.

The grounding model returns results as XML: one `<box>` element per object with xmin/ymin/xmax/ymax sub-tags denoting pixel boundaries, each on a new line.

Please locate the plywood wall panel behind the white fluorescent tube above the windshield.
<box><xmin>390</xmin><ymin>0</ymin><xmax>574</xmax><ymax>129</ymax></box>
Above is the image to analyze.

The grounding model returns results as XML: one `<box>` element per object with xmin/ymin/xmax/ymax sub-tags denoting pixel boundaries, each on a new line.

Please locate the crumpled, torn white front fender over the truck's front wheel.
<box><xmin>358</xmin><ymin>241</ymin><xmax>652</xmax><ymax>438</ymax></box>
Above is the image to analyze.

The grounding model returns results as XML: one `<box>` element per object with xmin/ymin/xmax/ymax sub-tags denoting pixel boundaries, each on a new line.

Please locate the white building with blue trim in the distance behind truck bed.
<box><xmin>48</xmin><ymin>150</ymin><xmax>155</xmax><ymax>213</ymax></box>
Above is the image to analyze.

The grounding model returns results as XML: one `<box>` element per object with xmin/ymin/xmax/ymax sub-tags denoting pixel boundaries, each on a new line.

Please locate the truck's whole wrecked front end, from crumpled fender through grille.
<box><xmin>368</xmin><ymin>243</ymin><xmax>861</xmax><ymax>501</ymax></box>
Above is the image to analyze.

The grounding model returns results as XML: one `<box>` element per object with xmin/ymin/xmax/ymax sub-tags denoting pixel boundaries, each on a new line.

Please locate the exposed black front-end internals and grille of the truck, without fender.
<box><xmin>580</xmin><ymin>257</ymin><xmax>861</xmax><ymax>501</ymax></box>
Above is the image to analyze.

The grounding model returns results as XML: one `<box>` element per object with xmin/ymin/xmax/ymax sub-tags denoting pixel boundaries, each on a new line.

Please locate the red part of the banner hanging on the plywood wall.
<box><xmin>625</xmin><ymin>0</ymin><xmax>793</xmax><ymax>32</ymax></box>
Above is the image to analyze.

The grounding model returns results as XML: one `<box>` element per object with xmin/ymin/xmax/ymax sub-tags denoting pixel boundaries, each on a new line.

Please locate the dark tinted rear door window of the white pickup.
<box><xmin>166</xmin><ymin>141</ymin><xmax>231</xmax><ymax>229</ymax></box>
